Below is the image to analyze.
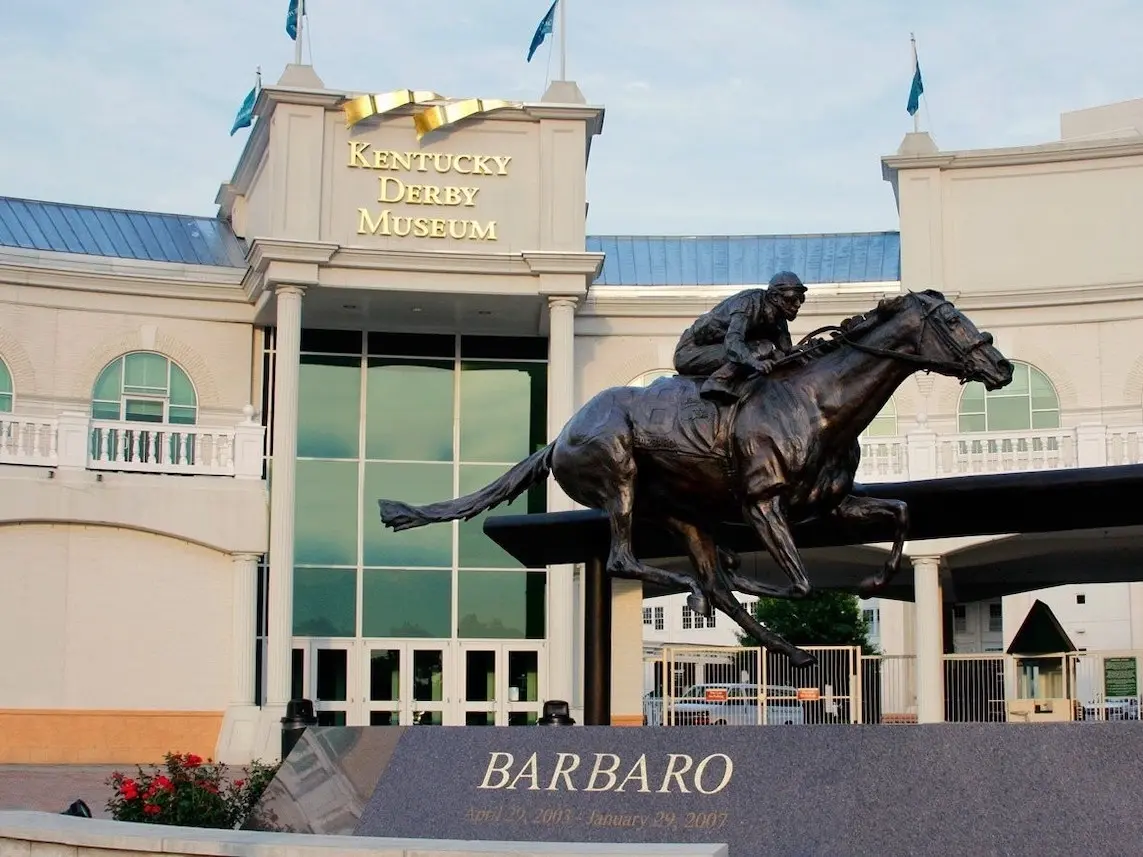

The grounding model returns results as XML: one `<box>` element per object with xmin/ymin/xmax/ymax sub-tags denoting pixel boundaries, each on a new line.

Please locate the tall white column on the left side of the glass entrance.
<box><xmin>266</xmin><ymin>286</ymin><xmax>303</xmax><ymax>708</ymax></box>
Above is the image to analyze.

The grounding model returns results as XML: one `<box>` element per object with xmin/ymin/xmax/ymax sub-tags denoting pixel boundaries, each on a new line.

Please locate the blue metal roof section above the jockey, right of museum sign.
<box><xmin>588</xmin><ymin>232</ymin><xmax>901</xmax><ymax>286</ymax></box>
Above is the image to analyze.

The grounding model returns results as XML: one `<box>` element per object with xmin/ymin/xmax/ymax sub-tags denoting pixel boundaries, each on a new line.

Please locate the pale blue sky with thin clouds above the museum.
<box><xmin>0</xmin><ymin>0</ymin><xmax>1143</xmax><ymax>234</ymax></box>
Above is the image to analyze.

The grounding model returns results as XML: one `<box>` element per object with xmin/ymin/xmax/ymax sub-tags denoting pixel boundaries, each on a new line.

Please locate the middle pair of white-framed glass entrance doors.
<box><xmin>360</xmin><ymin>642</ymin><xmax>450</xmax><ymax>726</ymax></box>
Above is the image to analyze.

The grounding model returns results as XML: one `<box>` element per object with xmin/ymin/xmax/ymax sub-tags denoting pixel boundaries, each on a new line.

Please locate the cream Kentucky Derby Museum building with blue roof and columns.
<box><xmin>0</xmin><ymin>65</ymin><xmax>1143</xmax><ymax>763</ymax></box>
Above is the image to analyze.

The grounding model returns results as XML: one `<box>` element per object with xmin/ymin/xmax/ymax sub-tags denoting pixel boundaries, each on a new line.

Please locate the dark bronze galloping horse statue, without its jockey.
<box><xmin>378</xmin><ymin>290</ymin><xmax>1013</xmax><ymax>667</ymax></box>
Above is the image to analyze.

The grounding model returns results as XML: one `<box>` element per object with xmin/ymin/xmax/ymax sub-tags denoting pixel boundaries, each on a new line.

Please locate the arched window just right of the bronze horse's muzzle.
<box><xmin>957</xmin><ymin>361</ymin><xmax>1060</xmax><ymax>433</ymax></box>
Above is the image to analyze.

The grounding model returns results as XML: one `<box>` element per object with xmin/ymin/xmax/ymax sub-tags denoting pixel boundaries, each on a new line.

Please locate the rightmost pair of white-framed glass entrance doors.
<box><xmin>459</xmin><ymin>642</ymin><xmax>544</xmax><ymax>726</ymax></box>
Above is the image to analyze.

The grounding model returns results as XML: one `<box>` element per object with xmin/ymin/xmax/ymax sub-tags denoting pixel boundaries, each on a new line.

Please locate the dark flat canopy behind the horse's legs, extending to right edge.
<box><xmin>485</xmin><ymin>465</ymin><xmax>1143</xmax><ymax>601</ymax></box>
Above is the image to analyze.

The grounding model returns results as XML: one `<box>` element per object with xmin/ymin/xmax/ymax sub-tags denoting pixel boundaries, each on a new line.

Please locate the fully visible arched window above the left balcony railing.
<box><xmin>91</xmin><ymin>351</ymin><xmax>198</xmax><ymax>425</ymax></box>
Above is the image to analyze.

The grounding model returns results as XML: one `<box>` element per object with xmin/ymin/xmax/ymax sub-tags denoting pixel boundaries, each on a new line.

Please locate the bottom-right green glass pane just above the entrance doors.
<box><xmin>456</xmin><ymin>571</ymin><xmax>547</xmax><ymax>640</ymax></box>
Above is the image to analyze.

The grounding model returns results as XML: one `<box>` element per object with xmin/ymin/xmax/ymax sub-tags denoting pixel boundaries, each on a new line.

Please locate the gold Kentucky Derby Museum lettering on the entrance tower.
<box><xmin>347</xmin><ymin>139</ymin><xmax>512</xmax><ymax>241</ymax></box>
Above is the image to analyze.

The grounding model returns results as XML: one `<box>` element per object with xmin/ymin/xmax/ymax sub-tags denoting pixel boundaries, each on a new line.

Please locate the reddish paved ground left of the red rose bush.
<box><xmin>0</xmin><ymin>764</ymin><xmax>120</xmax><ymax>818</ymax></box>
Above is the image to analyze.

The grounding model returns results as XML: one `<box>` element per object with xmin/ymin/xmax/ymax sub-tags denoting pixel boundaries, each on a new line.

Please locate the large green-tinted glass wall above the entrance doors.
<box><xmin>294</xmin><ymin>330</ymin><xmax>547</xmax><ymax>726</ymax></box>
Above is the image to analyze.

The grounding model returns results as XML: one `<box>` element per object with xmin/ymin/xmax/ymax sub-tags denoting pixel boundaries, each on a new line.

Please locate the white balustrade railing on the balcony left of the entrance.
<box><xmin>0</xmin><ymin>406</ymin><xmax>264</xmax><ymax>479</ymax></box>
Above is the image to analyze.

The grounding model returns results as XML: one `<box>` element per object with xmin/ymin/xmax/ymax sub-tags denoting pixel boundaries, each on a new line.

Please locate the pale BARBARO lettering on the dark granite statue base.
<box><xmin>477</xmin><ymin>752</ymin><xmax>734</xmax><ymax>794</ymax></box>
